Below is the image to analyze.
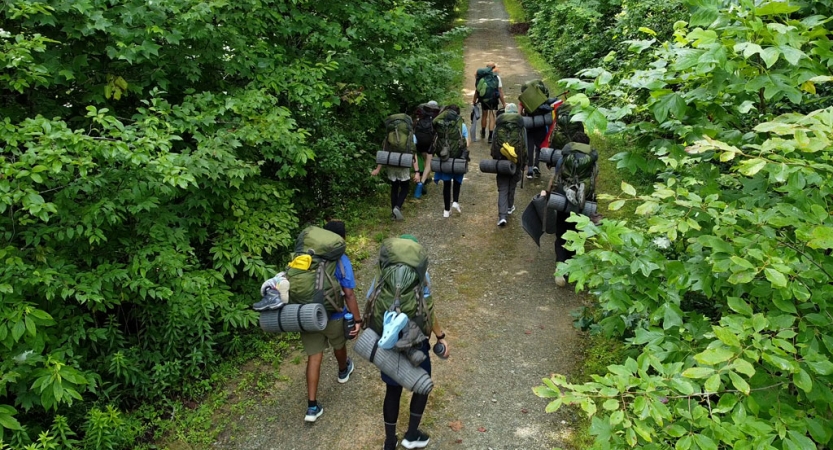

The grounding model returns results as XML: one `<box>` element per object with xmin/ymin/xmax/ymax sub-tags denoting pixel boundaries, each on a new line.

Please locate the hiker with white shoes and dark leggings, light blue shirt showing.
<box><xmin>434</xmin><ymin>105</ymin><xmax>471</xmax><ymax>218</ymax></box>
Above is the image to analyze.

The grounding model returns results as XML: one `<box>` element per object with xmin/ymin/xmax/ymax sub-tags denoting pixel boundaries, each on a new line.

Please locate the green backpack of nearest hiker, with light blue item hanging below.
<box><xmin>364</xmin><ymin>238</ymin><xmax>433</xmax><ymax>336</ymax></box>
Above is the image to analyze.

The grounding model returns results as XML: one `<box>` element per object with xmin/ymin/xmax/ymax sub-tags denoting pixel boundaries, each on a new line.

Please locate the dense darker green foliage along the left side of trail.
<box><xmin>0</xmin><ymin>0</ymin><xmax>459</xmax><ymax>449</ymax></box>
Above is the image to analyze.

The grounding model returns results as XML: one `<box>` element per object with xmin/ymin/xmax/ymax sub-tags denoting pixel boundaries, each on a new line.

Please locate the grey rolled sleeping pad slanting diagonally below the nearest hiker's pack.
<box><xmin>353</xmin><ymin>328</ymin><xmax>434</xmax><ymax>395</ymax></box>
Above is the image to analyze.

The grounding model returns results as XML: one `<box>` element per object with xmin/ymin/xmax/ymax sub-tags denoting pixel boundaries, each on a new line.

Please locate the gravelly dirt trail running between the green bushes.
<box><xmin>212</xmin><ymin>0</ymin><xmax>581</xmax><ymax>450</ymax></box>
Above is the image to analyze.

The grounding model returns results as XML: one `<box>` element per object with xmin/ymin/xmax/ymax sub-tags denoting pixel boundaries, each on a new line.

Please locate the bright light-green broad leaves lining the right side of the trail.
<box><xmin>535</xmin><ymin>0</ymin><xmax>833</xmax><ymax>450</ymax></box>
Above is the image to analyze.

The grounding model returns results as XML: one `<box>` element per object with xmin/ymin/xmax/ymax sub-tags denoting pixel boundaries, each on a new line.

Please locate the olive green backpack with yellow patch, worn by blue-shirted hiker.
<box><xmin>286</xmin><ymin>226</ymin><xmax>347</xmax><ymax>313</ymax></box>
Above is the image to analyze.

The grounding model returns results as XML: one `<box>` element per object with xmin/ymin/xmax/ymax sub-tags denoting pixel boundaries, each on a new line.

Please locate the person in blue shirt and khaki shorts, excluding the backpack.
<box><xmin>261</xmin><ymin>220</ymin><xmax>361</xmax><ymax>422</ymax></box>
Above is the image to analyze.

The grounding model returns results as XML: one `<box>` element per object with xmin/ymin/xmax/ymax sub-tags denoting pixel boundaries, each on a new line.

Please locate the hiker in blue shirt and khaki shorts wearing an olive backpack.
<box><xmin>261</xmin><ymin>220</ymin><xmax>362</xmax><ymax>422</ymax></box>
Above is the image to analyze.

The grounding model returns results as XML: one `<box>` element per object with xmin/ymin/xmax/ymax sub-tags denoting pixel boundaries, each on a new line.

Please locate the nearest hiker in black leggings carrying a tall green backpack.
<box><xmin>365</xmin><ymin>234</ymin><xmax>449</xmax><ymax>450</ymax></box>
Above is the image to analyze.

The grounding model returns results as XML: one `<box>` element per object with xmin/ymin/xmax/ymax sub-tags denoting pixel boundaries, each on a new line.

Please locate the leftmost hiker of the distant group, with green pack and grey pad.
<box><xmin>370</xmin><ymin>114</ymin><xmax>421</xmax><ymax>220</ymax></box>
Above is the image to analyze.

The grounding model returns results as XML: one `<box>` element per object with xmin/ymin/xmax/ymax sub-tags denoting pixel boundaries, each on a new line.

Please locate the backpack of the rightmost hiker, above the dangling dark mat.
<box><xmin>554</xmin><ymin>142</ymin><xmax>599</xmax><ymax>212</ymax></box>
